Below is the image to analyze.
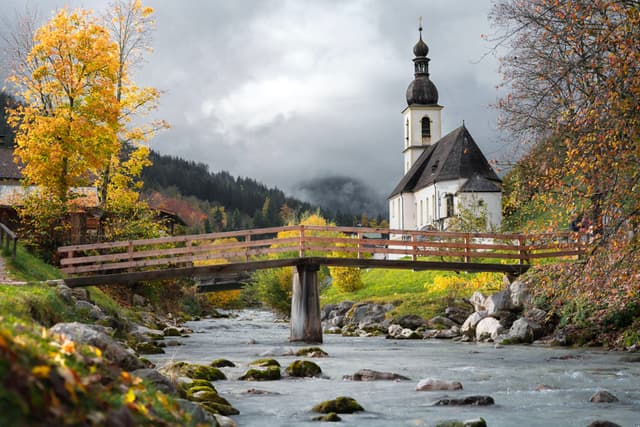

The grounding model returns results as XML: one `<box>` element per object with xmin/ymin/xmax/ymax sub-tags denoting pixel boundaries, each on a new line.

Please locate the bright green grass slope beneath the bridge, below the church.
<box><xmin>320</xmin><ymin>269</ymin><xmax>502</xmax><ymax>318</ymax></box>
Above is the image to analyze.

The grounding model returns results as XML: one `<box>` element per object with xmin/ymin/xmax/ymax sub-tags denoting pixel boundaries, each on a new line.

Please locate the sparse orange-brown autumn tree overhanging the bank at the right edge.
<box><xmin>491</xmin><ymin>0</ymin><xmax>640</xmax><ymax>334</ymax></box>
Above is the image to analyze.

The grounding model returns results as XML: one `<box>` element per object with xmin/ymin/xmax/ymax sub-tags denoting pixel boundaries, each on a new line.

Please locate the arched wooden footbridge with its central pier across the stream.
<box><xmin>58</xmin><ymin>225</ymin><xmax>585</xmax><ymax>342</ymax></box>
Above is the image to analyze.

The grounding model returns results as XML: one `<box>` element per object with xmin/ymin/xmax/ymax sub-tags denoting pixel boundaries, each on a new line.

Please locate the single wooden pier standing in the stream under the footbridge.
<box><xmin>289</xmin><ymin>264</ymin><xmax>322</xmax><ymax>343</ymax></box>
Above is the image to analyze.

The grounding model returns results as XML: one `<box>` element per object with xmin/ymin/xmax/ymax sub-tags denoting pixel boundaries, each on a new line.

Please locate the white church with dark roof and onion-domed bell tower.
<box><xmin>388</xmin><ymin>28</ymin><xmax>502</xmax><ymax>230</ymax></box>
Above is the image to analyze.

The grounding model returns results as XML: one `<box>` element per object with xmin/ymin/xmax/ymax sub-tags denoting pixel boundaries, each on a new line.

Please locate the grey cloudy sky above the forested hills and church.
<box><xmin>0</xmin><ymin>0</ymin><xmax>508</xmax><ymax>209</ymax></box>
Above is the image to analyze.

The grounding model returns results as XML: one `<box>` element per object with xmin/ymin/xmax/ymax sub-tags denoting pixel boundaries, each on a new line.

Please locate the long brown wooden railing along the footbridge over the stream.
<box><xmin>58</xmin><ymin>225</ymin><xmax>584</xmax><ymax>275</ymax></box>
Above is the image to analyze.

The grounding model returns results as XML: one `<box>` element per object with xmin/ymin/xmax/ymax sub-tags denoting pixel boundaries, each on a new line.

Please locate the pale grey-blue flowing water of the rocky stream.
<box><xmin>150</xmin><ymin>310</ymin><xmax>640</xmax><ymax>427</ymax></box>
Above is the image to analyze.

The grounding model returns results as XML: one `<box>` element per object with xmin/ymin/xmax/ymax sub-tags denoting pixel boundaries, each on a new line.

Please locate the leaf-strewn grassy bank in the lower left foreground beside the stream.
<box><xmin>0</xmin><ymin>247</ymin><xmax>205</xmax><ymax>427</ymax></box>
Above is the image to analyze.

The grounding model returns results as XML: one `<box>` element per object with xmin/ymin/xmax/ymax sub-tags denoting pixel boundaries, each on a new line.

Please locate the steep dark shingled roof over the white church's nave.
<box><xmin>389</xmin><ymin>125</ymin><xmax>502</xmax><ymax>198</ymax></box>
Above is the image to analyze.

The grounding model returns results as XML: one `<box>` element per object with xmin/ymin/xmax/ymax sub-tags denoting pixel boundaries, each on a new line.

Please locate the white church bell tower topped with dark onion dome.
<box><xmin>402</xmin><ymin>22</ymin><xmax>443</xmax><ymax>174</ymax></box>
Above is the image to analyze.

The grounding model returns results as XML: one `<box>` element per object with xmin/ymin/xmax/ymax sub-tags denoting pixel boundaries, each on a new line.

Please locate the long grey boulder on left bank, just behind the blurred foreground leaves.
<box><xmin>49</xmin><ymin>322</ymin><xmax>146</xmax><ymax>371</ymax></box>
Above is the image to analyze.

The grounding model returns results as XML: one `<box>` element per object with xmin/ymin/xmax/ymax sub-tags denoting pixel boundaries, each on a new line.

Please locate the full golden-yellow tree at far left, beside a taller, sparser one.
<box><xmin>9</xmin><ymin>10</ymin><xmax>119</xmax><ymax>203</ymax></box>
